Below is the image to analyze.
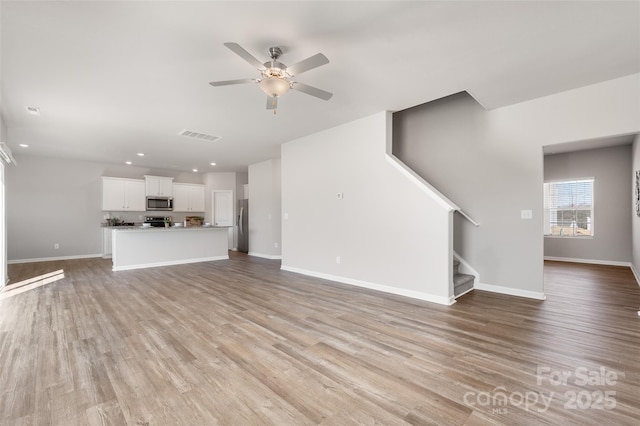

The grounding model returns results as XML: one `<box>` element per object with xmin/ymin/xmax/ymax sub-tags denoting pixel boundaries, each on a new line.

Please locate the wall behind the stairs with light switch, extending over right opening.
<box><xmin>394</xmin><ymin>74</ymin><xmax>640</xmax><ymax>294</ymax></box>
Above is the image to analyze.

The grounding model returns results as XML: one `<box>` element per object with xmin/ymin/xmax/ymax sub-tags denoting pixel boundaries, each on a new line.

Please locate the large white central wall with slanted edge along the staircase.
<box><xmin>282</xmin><ymin>112</ymin><xmax>451</xmax><ymax>303</ymax></box>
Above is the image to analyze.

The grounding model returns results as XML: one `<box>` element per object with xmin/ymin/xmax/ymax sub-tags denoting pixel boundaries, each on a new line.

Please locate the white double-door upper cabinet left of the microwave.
<box><xmin>102</xmin><ymin>177</ymin><xmax>146</xmax><ymax>212</ymax></box>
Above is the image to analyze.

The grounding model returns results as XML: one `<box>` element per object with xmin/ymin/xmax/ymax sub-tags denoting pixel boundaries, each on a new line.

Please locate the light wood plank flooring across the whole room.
<box><xmin>0</xmin><ymin>253</ymin><xmax>640</xmax><ymax>426</ymax></box>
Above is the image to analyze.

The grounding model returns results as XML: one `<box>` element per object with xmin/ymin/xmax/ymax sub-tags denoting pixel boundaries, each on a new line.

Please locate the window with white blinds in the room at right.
<box><xmin>544</xmin><ymin>178</ymin><xmax>594</xmax><ymax>237</ymax></box>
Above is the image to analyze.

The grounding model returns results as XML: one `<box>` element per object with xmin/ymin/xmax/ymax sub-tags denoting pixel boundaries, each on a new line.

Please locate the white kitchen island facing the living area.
<box><xmin>112</xmin><ymin>227</ymin><xmax>229</xmax><ymax>271</ymax></box>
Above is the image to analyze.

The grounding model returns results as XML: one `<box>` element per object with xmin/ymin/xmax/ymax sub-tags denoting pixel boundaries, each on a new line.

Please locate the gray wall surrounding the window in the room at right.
<box><xmin>544</xmin><ymin>145</ymin><xmax>632</xmax><ymax>263</ymax></box>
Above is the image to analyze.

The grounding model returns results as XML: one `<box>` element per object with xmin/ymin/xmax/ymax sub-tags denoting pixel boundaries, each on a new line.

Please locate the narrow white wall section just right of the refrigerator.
<box><xmin>249</xmin><ymin>159</ymin><xmax>282</xmax><ymax>259</ymax></box>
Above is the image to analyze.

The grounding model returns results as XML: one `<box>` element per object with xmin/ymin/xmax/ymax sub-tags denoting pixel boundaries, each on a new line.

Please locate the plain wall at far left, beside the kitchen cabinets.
<box><xmin>6</xmin><ymin>156</ymin><xmax>104</xmax><ymax>261</ymax></box>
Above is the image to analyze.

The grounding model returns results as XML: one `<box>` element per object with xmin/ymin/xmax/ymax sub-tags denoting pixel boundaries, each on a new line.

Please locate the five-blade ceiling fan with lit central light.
<box><xmin>209</xmin><ymin>42</ymin><xmax>333</xmax><ymax>114</ymax></box>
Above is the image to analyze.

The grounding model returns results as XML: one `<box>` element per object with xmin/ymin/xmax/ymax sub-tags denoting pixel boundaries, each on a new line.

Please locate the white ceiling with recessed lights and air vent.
<box><xmin>0</xmin><ymin>1</ymin><xmax>640</xmax><ymax>172</ymax></box>
